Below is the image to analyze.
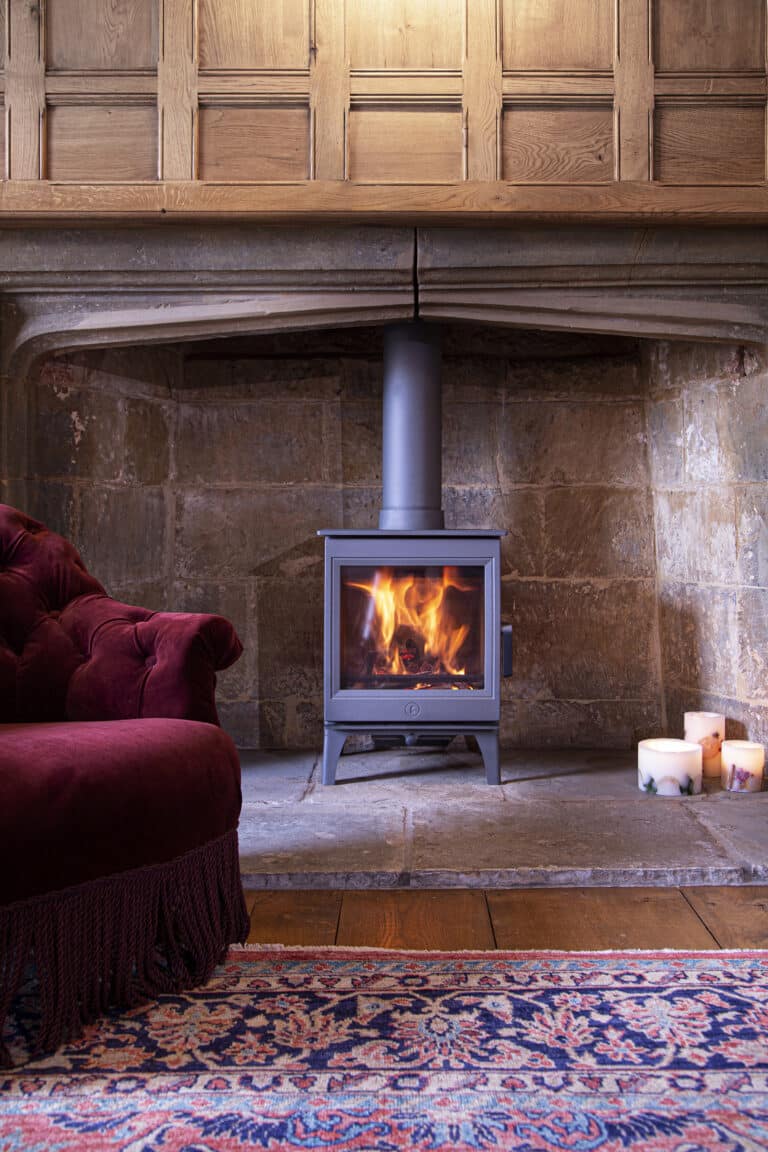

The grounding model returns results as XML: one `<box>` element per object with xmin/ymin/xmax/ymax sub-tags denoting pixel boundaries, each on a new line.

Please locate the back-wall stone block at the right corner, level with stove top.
<box><xmin>545</xmin><ymin>487</ymin><xmax>654</xmax><ymax>578</ymax></box>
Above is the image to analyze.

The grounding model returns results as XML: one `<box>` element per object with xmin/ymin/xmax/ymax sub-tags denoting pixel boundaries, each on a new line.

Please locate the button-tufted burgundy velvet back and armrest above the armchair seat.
<box><xmin>0</xmin><ymin>505</ymin><xmax>242</xmax><ymax>723</ymax></box>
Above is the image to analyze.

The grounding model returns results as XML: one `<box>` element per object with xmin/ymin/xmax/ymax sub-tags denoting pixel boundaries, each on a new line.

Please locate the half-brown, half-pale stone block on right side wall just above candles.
<box><xmin>660</xmin><ymin>582</ymin><xmax>739</xmax><ymax>697</ymax></box>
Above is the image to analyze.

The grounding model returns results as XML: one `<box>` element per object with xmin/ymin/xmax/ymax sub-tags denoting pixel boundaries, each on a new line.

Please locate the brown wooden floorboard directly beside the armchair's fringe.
<box><xmin>245</xmin><ymin>890</ymin><xmax>342</xmax><ymax>948</ymax></box>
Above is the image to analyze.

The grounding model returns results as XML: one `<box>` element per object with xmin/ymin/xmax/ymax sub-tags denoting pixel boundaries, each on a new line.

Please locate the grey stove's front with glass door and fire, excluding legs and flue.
<box><xmin>325</xmin><ymin>536</ymin><xmax>500</xmax><ymax>723</ymax></box>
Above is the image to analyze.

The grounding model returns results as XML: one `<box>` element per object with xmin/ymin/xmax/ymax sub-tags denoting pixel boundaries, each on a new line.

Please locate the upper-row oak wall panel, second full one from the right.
<box><xmin>502</xmin><ymin>0</ymin><xmax>614</xmax><ymax>71</ymax></box>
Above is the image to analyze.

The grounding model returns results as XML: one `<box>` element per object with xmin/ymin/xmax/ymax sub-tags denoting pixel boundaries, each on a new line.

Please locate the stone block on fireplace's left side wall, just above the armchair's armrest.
<box><xmin>75</xmin><ymin>486</ymin><xmax>168</xmax><ymax>591</ymax></box>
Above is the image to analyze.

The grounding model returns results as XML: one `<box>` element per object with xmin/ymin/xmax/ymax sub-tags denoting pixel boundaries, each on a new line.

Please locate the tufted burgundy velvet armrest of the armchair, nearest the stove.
<box><xmin>61</xmin><ymin>596</ymin><xmax>243</xmax><ymax>723</ymax></box>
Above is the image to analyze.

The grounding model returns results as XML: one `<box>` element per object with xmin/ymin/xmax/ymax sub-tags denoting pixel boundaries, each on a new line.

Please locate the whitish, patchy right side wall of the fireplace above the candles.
<box><xmin>644</xmin><ymin>343</ymin><xmax>768</xmax><ymax>742</ymax></box>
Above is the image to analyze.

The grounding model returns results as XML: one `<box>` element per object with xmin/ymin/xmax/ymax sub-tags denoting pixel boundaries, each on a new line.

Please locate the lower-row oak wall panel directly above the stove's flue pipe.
<box><xmin>348</xmin><ymin>108</ymin><xmax>463</xmax><ymax>183</ymax></box>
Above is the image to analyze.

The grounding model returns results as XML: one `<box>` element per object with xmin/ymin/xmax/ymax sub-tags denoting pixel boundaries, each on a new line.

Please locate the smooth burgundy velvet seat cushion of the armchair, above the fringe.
<box><xmin>0</xmin><ymin>719</ymin><xmax>241</xmax><ymax>908</ymax></box>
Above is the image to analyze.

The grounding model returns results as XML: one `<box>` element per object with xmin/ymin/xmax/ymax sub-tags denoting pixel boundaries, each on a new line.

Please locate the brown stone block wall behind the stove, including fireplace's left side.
<box><xmin>17</xmin><ymin>326</ymin><xmax>671</xmax><ymax>748</ymax></box>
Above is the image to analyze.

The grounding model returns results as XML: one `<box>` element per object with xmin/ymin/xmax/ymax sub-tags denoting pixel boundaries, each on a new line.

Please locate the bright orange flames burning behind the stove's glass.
<box><xmin>349</xmin><ymin>568</ymin><xmax>476</xmax><ymax>676</ymax></box>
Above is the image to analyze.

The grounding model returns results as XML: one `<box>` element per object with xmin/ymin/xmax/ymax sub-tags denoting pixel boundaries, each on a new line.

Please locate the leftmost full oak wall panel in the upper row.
<box><xmin>45</xmin><ymin>0</ymin><xmax>158</xmax><ymax>69</ymax></box>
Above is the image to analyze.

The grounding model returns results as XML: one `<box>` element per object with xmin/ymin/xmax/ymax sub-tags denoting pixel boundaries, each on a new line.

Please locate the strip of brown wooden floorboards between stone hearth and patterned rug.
<box><xmin>245</xmin><ymin>887</ymin><xmax>768</xmax><ymax>952</ymax></box>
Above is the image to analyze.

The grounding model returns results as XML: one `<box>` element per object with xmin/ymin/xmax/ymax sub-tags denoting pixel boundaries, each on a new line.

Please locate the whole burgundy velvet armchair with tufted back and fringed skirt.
<box><xmin>0</xmin><ymin>505</ymin><xmax>248</xmax><ymax>1063</ymax></box>
